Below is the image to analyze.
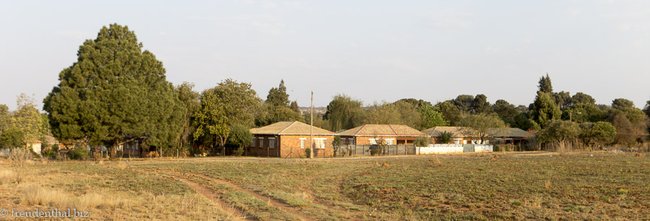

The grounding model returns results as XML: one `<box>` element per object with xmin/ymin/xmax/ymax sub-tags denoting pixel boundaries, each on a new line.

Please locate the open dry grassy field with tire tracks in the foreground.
<box><xmin>0</xmin><ymin>153</ymin><xmax>650</xmax><ymax>220</ymax></box>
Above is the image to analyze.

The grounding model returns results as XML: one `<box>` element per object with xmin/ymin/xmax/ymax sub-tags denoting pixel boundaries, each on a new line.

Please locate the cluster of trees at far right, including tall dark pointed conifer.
<box><xmin>525</xmin><ymin>75</ymin><xmax>650</xmax><ymax>149</ymax></box>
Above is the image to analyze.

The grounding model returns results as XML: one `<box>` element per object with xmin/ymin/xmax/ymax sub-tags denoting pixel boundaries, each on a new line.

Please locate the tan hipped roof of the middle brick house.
<box><xmin>338</xmin><ymin>124</ymin><xmax>424</xmax><ymax>137</ymax></box>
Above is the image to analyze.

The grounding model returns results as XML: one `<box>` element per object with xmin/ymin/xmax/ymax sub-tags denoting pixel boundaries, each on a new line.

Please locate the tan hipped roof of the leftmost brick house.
<box><xmin>250</xmin><ymin>121</ymin><xmax>334</xmax><ymax>136</ymax></box>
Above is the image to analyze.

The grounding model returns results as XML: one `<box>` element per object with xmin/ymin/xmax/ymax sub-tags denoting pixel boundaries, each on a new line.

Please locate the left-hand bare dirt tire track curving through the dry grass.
<box><xmin>159</xmin><ymin>174</ymin><xmax>255</xmax><ymax>220</ymax></box>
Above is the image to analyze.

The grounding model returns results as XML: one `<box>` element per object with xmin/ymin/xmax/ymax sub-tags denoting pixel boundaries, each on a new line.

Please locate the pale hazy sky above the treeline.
<box><xmin>0</xmin><ymin>0</ymin><xmax>650</xmax><ymax>109</ymax></box>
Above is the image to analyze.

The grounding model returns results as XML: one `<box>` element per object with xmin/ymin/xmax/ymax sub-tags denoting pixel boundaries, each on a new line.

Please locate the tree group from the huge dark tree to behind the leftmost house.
<box><xmin>34</xmin><ymin>24</ymin><xmax>302</xmax><ymax>155</ymax></box>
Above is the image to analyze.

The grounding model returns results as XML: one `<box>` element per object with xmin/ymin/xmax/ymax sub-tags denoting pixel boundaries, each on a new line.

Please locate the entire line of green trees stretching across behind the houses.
<box><xmin>0</xmin><ymin>24</ymin><xmax>650</xmax><ymax>153</ymax></box>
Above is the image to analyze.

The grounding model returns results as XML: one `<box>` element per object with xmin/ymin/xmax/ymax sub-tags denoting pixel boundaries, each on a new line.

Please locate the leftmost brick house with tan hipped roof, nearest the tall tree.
<box><xmin>246</xmin><ymin>121</ymin><xmax>334</xmax><ymax>158</ymax></box>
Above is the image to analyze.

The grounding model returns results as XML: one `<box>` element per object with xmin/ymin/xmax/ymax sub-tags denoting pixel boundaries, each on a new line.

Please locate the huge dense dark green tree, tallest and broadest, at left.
<box><xmin>44</xmin><ymin>24</ymin><xmax>185</xmax><ymax>152</ymax></box>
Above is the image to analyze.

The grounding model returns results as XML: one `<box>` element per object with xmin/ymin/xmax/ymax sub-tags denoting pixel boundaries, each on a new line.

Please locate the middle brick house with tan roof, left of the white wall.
<box><xmin>337</xmin><ymin>124</ymin><xmax>424</xmax><ymax>145</ymax></box>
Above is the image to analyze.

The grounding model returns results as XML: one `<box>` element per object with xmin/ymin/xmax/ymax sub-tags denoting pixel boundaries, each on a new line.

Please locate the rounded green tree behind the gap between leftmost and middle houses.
<box><xmin>323</xmin><ymin>95</ymin><xmax>365</xmax><ymax>131</ymax></box>
